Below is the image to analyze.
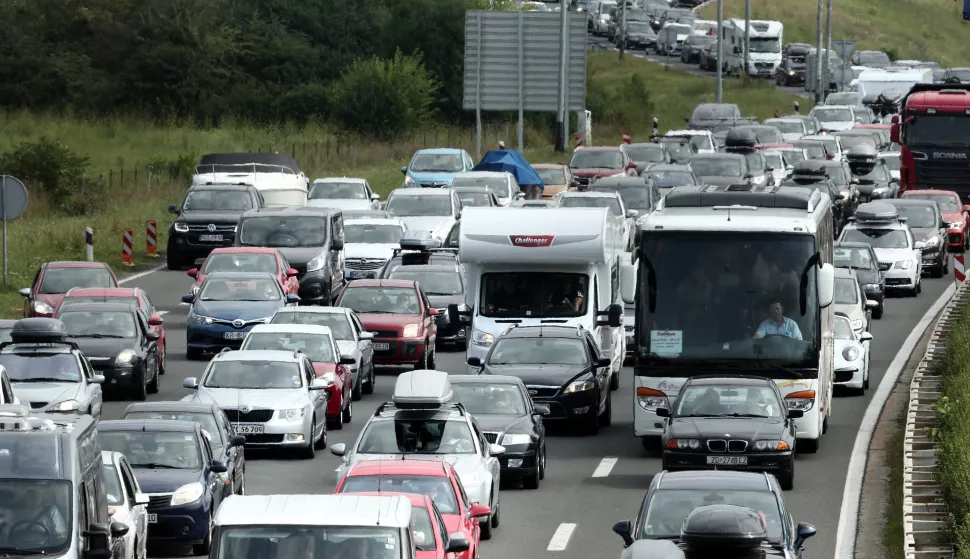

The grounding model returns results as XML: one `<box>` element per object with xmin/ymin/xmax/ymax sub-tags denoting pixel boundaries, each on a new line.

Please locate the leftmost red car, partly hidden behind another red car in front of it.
<box><xmin>20</xmin><ymin>261</ymin><xmax>118</xmax><ymax>318</ymax></box>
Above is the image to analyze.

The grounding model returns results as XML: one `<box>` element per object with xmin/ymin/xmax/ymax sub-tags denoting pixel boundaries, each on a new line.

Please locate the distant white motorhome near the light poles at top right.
<box><xmin>722</xmin><ymin>19</ymin><xmax>784</xmax><ymax>78</ymax></box>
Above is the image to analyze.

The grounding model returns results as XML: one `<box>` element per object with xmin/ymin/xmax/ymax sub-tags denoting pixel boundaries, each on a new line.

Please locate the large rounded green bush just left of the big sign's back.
<box><xmin>331</xmin><ymin>51</ymin><xmax>440</xmax><ymax>138</ymax></box>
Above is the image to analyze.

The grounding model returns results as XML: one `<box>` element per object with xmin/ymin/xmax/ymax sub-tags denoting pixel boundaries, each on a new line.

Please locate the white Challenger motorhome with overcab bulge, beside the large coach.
<box><xmin>448</xmin><ymin>208</ymin><xmax>636</xmax><ymax>386</ymax></box>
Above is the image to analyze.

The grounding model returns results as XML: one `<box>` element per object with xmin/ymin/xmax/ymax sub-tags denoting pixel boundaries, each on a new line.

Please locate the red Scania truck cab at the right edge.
<box><xmin>890</xmin><ymin>83</ymin><xmax>970</xmax><ymax>200</ymax></box>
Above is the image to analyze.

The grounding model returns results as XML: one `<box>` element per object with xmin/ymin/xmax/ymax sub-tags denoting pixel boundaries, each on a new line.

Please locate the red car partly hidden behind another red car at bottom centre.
<box><xmin>334</xmin><ymin>460</ymin><xmax>492</xmax><ymax>559</ymax></box>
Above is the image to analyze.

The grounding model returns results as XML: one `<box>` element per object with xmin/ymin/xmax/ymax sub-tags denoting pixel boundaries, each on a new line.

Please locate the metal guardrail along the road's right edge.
<box><xmin>903</xmin><ymin>283</ymin><xmax>970</xmax><ymax>559</ymax></box>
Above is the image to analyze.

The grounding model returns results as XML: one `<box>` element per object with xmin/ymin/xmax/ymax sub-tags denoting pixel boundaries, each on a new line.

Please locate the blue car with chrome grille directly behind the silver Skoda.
<box><xmin>182</xmin><ymin>272</ymin><xmax>300</xmax><ymax>359</ymax></box>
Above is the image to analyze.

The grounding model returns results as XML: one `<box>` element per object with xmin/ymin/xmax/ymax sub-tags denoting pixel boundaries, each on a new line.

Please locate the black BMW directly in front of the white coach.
<box><xmin>657</xmin><ymin>375</ymin><xmax>803</xmax><ymax>489</ymax></box>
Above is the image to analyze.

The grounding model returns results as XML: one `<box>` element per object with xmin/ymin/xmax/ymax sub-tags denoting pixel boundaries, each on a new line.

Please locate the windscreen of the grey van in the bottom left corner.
<box><xmin>0</xmin><ymin>480</ymin><xmax>73</xmax><ymax>557</ymax></box>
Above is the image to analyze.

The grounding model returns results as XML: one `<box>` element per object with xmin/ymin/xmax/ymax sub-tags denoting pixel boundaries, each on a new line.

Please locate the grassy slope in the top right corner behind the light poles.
<box><xmin>701</xmin><ymin>0</ymin><xmax>970</xmax><ymax>68</ymax></box>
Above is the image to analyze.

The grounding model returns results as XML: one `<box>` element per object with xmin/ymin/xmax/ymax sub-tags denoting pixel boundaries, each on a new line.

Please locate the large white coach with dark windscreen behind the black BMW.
<box><xmin>633</xmin><ymin>185</ymin><xmax>835</xmax><ymax>452</ymax></box>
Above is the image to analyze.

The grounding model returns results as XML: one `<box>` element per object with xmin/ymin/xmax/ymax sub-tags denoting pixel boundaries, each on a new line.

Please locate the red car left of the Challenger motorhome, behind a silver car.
<box><xmin>334</xmin><ymin>280</ymin><xmax>438</xmax><ymax>369</ymax></box>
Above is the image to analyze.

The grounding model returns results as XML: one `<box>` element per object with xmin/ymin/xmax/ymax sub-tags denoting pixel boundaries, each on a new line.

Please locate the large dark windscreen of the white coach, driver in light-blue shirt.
<box><xmin>637</xmin><ymin>231</ymin><xmax>820</xmax><ymax>376</ymax></box>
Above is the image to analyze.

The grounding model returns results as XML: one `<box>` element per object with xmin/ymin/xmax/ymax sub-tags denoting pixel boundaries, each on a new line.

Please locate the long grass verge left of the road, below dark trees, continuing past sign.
<box><xmin>0</xmin><ymin>53</ymin><xmax>795</xmax><ymax>317</ymax></box>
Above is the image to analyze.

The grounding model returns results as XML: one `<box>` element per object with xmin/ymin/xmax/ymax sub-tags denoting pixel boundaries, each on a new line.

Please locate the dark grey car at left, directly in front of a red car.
<box><xmin>57</xmin><ymin>303</ymin><xmax>161</xmax><ymax>400</ymax></box>
